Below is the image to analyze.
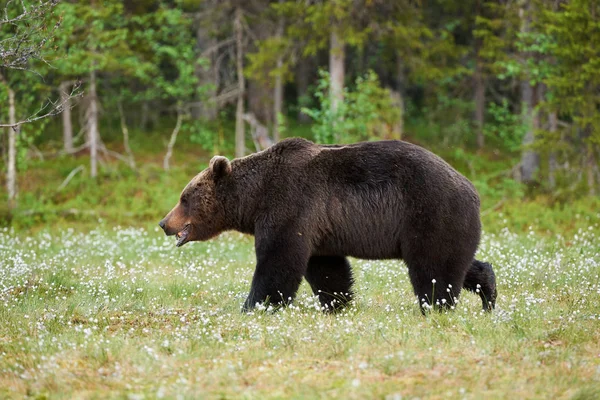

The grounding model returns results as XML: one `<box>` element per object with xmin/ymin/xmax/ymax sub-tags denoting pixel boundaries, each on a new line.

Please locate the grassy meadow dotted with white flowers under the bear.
<box><xmin>0</xmin><ymin>224</ymin><xmax>600</xmax><ymax>399</ymax></box>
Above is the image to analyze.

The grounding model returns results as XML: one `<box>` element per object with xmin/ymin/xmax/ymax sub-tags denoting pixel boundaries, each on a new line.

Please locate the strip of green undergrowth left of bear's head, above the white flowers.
<box><xmin>5</xmin><ymin>154</ymin><xmax>206</xmax><ymax>228</ymax></box>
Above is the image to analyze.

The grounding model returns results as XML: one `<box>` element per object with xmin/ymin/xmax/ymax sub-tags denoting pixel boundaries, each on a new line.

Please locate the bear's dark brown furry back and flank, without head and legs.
<box><xmin>258</xmin><ymin>139</ymin><xmax>480</xmax><ymax>258</ymax></box>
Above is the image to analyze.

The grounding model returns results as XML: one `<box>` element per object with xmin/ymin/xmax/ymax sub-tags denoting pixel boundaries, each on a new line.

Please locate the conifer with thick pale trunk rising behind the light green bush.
<box><xmin>248</xmin><ymin>0</ymin><xmax>433</xmax><ymax>141</ymax></box>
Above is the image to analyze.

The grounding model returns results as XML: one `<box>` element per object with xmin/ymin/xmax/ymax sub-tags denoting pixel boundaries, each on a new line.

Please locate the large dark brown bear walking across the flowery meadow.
<box><xmin>159</xmin><ymin>138</ymin><xmax>496</xmax><ymax>311</ymax></box>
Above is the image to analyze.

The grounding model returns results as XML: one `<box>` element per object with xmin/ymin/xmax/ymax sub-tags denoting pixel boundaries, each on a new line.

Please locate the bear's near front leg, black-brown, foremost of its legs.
<box><xmin>242</xmin><ymin>230</ymin><xmax>310</xmax><ymax>312</ymax></box>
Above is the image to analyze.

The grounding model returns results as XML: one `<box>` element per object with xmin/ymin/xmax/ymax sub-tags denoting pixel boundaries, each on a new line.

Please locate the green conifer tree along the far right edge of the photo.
<box><xmin>536</xmin><ymin>0</ymin><xmax>600</xmax><ymax>195</ymax></box>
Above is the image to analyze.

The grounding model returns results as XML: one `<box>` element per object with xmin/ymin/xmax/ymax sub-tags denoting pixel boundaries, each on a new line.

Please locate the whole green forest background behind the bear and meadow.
<box><xmin>0</xmin><ymin>0</ymin><xmax>600</xmax><ymax>225</ymax></box>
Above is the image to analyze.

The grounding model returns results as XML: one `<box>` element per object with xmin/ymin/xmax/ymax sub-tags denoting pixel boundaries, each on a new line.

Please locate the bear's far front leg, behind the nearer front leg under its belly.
<box><xmin>305</xmin><ymin>256</ymin><xmax>354</xmax><ymax>311</ymax></box>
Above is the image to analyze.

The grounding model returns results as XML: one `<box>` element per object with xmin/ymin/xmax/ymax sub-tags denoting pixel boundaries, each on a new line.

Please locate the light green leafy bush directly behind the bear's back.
<box><xmin>302</xmin><ymin>71</ymin><xmax>401</xmax><ymax>143</ymax></box>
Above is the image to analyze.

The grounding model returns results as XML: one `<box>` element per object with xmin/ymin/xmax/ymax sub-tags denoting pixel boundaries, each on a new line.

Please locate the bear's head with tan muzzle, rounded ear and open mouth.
<box><xmin>158</xmin><ymin>156</ymin><xmax>231</xmax><ymax>247</ymax></box>
